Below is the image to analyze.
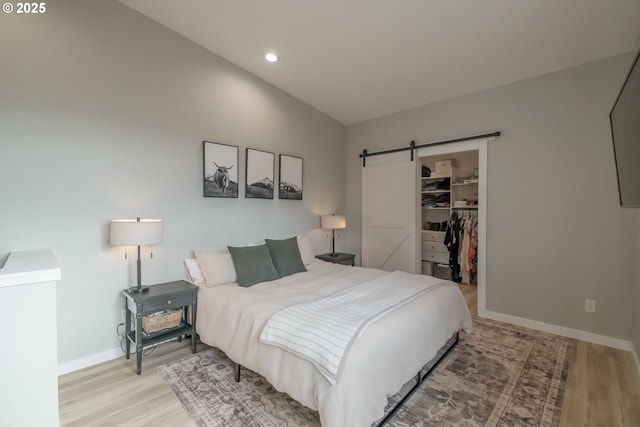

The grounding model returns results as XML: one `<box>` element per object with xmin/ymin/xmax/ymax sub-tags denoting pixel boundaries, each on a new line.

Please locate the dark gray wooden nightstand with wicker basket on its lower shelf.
<box><xmin>122</xmin><ymin>280</ymin><xmax>198</xmax><ymax>375</ymax></box>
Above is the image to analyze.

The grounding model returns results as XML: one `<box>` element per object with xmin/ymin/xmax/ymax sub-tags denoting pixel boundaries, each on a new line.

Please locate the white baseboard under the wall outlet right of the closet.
<box><xmin>478</xmin><ymin>310</ymin><xmax>638</xmax><ymax>352</ymax></box>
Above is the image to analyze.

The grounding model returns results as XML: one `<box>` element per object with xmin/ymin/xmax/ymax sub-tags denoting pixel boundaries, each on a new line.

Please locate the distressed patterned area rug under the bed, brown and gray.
<box><xmin>158</xmin><ymin>319</ymin><xmax>575</xmax><ymax>427</ymax></box>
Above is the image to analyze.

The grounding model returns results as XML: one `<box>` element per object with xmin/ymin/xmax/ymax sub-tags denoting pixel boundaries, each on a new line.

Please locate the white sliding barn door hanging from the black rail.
<box><xmin>362</xmin><ymin>151</ymin><xmax>418</xmax><ymax>273</ymax></box>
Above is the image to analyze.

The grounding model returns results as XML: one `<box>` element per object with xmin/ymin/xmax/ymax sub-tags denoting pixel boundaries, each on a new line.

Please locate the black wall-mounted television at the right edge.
<box><xmin>609</xmin><ymin>51</ymin><xmax>640</xmax><ymax>208</ymax></box>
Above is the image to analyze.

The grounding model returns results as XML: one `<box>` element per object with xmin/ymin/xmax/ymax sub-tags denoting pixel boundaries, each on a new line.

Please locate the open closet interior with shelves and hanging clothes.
<box><xmin>418</xmin><ymin>150</ymin><xmax>481</xmax><ymax>284</ymax></box>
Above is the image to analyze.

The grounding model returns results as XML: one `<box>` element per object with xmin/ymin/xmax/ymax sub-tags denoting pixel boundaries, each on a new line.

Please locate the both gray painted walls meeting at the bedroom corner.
<box><xmin>0</xmin><ymin>1</ymin><xmax>640</xmax><ymax>368</ymax></box>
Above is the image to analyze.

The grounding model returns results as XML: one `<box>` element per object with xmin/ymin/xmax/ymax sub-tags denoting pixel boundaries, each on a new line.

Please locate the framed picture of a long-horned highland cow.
<box><xmin>203</xmin><ymin>141</ymin><xmax>238</xmax><ymax>198</ymax></box>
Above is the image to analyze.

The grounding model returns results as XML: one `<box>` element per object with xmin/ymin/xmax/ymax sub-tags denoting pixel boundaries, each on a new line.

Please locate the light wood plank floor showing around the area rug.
<box><xmin>59</xmin><ymin>285</ymin><xmax>640</xmax><ymax>427</ymax></box>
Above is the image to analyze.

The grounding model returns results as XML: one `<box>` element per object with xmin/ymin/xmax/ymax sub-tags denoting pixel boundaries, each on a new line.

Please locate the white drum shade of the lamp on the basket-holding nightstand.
<box><xmin>110</xmin><ymin>219</ymin><xmax>164</xmax><ymax>246</ymax></box>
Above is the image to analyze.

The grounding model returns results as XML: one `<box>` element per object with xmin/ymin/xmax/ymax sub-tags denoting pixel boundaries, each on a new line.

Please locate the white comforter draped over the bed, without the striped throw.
<box><xmin>196</xmin><ymin>260</ymin><xmax>471</xmax><ymax>427</ymax></box>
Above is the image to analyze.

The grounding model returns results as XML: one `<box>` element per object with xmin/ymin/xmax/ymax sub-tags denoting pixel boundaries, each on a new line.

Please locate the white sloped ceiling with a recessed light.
<box><xmin>121</xmin><ymin>0</ymin><xmax>640</xmax><ymax>125</ymax></box>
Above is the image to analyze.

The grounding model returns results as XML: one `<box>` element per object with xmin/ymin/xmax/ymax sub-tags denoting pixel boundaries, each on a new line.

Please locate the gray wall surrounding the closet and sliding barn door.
<box><xmin>347</xmin><ymin>54</ymin><xmax>640</xmax><ymax>348</ymax></box>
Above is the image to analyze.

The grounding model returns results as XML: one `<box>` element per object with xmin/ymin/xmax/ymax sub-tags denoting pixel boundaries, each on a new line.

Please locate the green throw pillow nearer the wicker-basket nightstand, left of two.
<box><xmin>228</xmin><ymin>245</ymin><xmax>278</xmax><ymax>287</ymax></box>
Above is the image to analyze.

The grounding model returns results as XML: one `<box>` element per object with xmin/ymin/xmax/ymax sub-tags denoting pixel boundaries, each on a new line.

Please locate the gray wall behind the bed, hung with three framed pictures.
<box><xmin>0</xmin><ymin>0</ymin><xmax>346</xmax><ymax>362</ymax></box>
